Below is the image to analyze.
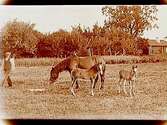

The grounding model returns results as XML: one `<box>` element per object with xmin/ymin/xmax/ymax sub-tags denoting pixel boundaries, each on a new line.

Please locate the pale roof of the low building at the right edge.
<box><xmin>148</xmin><ymin>40</ymin><xmax>167</xmax><ymax>47</ymax></box>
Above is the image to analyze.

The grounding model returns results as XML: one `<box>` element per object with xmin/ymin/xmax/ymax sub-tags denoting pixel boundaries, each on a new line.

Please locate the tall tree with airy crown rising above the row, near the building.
<box><xmin>102</xmin><ymin>6</ymin><xmax>158</xmax><ymax>37</ymax></box>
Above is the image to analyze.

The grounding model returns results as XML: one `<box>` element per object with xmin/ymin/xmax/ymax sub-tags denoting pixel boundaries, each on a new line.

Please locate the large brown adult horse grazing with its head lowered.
<box><xmin>50</xmin><ymin>55</ymin><xmax>106</xmax><ymax>89</ymax></box>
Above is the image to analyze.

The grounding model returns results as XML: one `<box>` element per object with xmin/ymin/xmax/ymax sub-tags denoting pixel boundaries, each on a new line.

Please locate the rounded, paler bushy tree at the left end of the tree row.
<box><xmin>2</xmin><ymin>19</ymin><xmax>41</xmax><ymax>56</ymax></box>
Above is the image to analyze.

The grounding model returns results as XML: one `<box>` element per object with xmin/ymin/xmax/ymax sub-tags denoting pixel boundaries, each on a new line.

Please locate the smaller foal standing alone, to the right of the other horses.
<box><xmin>119</xmin><ymin>65</ymin><xmax>137</xmax><ymax>96</ymax></box>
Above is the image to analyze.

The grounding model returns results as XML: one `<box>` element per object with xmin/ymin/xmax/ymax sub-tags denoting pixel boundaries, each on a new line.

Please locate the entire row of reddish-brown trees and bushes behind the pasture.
<box><xmin>1</xmin><ymin>6</ymin><xmax>158</xmax><ymax>57</ymax></box>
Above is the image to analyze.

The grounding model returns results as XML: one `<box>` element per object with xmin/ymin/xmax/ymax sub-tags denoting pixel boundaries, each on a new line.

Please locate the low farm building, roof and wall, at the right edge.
<box><xmin>148</xmin><ymin>40</ymin><xmax>167</xmax><ymax>55</ymax></box>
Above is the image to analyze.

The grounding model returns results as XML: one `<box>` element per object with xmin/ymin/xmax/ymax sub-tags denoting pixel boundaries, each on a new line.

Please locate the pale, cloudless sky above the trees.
<box><xmin>0</xmin><ymin>5</ymin><xmax>167</xmax><ymax>39</ymax></box>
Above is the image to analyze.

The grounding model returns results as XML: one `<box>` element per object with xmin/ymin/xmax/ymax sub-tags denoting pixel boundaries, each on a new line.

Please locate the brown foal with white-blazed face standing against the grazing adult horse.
<box><xmin>70</xmin><ymin>64</ymin><xmax>103</xmax><ymax>96</ymax></box>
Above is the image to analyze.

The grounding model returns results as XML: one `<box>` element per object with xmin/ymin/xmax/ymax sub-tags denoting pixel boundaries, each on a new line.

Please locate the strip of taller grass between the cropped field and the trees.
<box><xmin>13</xmin><ymin>56</ymin><xmax>167</xmax><ymax>67</ymax></box>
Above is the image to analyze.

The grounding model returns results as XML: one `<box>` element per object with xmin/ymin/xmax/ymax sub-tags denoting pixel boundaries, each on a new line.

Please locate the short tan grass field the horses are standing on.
<box><xmin>0</xmin><ymin>62</ymin><xmax>167</xmax><ymax>119</ymax></box>
